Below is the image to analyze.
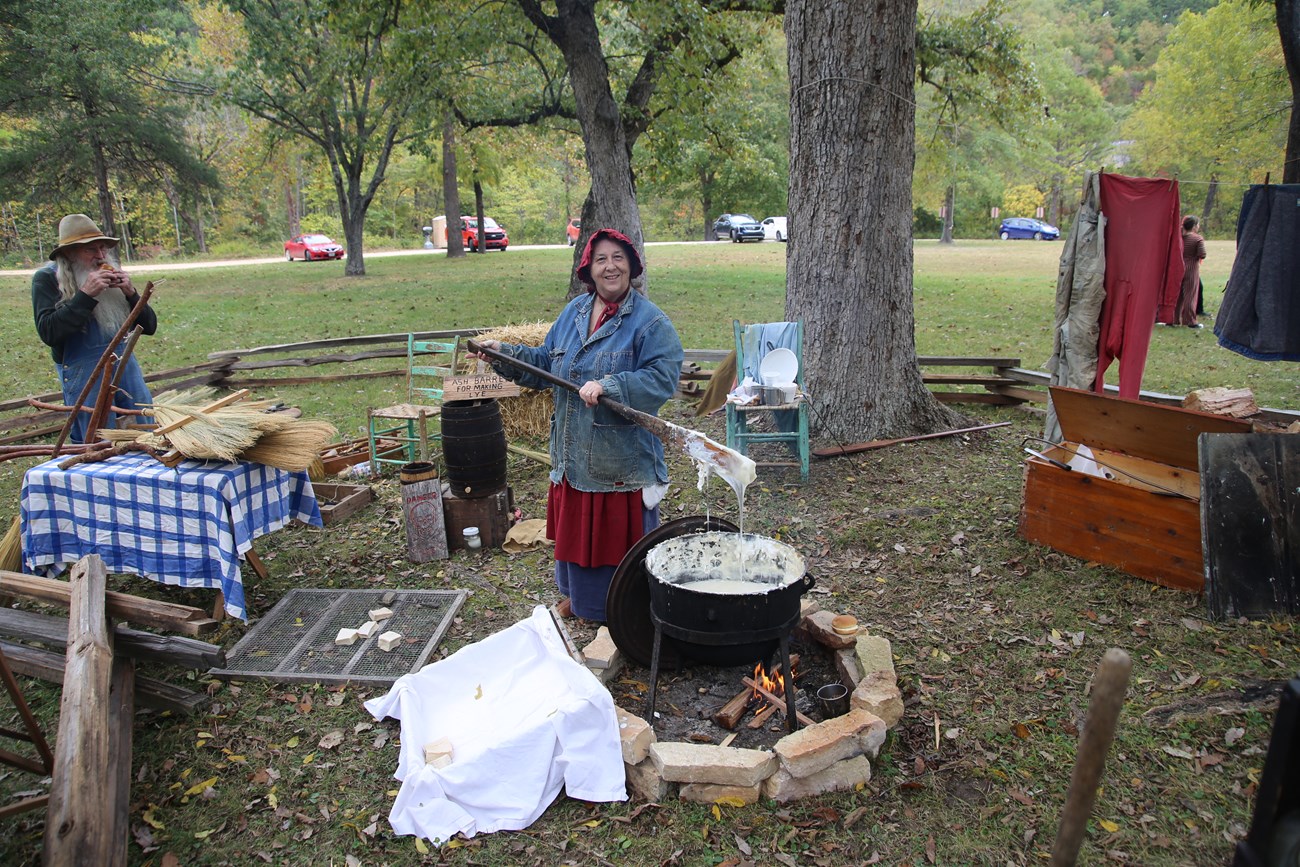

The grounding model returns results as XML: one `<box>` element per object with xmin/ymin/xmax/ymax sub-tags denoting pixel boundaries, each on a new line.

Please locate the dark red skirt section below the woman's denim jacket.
<box><xmin>546</xmin><ymin>478</ymin><xmax>645</xmax><ymax>568</ymax></box>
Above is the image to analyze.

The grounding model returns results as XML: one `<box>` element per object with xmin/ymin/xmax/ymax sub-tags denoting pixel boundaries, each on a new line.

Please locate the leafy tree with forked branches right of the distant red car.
<box><xmin>222</xmin><ymin>0</ymin><xmax>444</xmax><ymax>276</ymax></box>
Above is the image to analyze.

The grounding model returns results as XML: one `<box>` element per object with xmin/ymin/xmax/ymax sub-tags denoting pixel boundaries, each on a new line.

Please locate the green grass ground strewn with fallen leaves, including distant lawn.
<box><xmin>0</xmin><ymin>242</ymin><xmax>1300</xmax><ymax>867</ymax></box>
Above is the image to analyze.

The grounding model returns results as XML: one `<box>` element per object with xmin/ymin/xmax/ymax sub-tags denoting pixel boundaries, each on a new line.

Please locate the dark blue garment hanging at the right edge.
<box><xmin>1214</xmin><ymin>183</ymin><xmax>1300</xmax><ymax>361</ymax></box>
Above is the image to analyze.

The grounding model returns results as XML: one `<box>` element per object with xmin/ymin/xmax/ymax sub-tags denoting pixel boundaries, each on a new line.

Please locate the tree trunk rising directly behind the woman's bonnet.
<box><xmin>520</xmin><ymin>0</ymin><xmax>646</xmax><ymax>298</ymax></box>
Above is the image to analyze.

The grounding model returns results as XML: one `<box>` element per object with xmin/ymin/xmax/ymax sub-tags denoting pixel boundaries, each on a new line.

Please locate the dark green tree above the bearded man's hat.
<box><xmin>0</xmin><ymin>0</ymin><xmax>217</xmax><ymax>243</ymax></box>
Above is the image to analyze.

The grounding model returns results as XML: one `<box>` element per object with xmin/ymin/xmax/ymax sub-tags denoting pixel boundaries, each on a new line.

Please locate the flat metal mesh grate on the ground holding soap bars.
<box><xmin>211</xmin><ymin>589</ymin><xmax>467</xmax><ymax>685</ymax></box>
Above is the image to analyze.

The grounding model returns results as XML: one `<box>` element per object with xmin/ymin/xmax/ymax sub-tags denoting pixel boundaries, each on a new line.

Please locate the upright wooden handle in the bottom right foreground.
<box><xmin>1049</xmin><ymin>647</ymin><xmax>1132</xmax><ymax>867</ymax></box>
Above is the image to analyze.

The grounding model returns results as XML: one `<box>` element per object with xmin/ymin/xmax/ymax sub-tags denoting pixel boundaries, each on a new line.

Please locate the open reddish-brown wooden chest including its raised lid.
<box><xmin>1021</xmin><ymin>386</ymin><xmax>1251</xmax><ymax>591</ymax></box>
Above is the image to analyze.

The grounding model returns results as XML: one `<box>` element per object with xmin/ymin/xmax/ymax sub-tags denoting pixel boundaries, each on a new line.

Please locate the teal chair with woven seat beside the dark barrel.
<box><xmin>368</xmin><ymin>334</ymin><xmax>460</xmax><ymax>474</ymax></box>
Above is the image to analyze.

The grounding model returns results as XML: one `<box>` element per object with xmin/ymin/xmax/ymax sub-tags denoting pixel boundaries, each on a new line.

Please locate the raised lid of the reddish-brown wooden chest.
<box><xmin>1049</xmin><ymin>386</ymin><xmax>1251</xmax><ymax>472</ymax></box>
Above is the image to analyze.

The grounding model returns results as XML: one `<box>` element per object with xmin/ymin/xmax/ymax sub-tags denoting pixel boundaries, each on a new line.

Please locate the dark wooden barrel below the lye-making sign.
<box><xmin>442</xmin><ymin>398</ymin><xmax>506</xmax><ymax>498</ymax></box>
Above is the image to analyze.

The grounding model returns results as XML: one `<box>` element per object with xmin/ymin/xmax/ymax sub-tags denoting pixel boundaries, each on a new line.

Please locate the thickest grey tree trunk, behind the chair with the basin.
<box><xmin>785</xmin><ymin>0</ymin><xmax>961</xmax><ymax>442</ymax></box>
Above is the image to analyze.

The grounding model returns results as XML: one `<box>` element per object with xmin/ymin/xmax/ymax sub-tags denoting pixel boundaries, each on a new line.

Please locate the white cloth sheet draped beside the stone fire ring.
<box><xmin>365</xmin><ymin>606</ymin><xmax>628</xmax><ymax>842</ymax></box>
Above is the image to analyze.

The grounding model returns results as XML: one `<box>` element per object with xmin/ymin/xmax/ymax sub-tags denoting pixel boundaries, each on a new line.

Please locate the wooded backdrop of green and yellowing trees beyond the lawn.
<box><xmin>0</xmin><ymin>0</ymin><xmax>1300</xmax><ymax>265</ymax></box>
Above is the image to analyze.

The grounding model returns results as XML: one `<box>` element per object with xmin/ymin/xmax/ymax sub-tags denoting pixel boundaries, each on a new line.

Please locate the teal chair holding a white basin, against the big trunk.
<box><xmin>727</xmin><ymin>320</ymin><xmax>810</xmax><ymax>482</ymax></box>
